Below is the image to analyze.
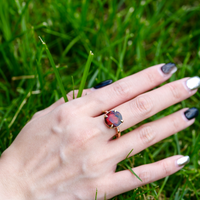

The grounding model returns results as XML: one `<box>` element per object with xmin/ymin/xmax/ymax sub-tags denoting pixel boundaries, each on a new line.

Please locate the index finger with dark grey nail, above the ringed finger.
<box><xmin>82</xmin><ymin>63</ymin><xmax>177</xmax><ymax>116</ymax></box>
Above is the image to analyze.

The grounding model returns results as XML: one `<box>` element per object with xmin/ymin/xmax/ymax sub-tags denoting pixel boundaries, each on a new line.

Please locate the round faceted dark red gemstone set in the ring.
<box><xmin>105</xmin><ymin>110</ymin><xmax>122</xmax><ymax>128</ymax></box>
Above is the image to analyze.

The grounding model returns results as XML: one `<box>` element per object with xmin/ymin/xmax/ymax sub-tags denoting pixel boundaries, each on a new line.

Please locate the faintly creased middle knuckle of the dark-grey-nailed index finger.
<box><xmin>113</xmin><ymin>81</ymin><xmax>130</xmax><ymax>98</ymax></box>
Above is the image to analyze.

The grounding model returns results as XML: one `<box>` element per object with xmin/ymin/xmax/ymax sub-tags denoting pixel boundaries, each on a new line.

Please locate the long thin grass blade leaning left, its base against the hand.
<box><xmin>39</xmin><ymin>36</ymin><xmax>68</xmax><ymax>102</ymax></box>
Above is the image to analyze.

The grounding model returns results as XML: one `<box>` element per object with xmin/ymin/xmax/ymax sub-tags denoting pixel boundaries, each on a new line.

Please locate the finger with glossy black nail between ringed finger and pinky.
<box><xmin>110</xmin><ymin>108</ymin><xmax>198</xmax><ymax>163</ymax></box>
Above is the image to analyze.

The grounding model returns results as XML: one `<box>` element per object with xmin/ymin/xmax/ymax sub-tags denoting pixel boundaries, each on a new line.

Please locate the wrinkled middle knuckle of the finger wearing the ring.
<box><xmin>134</xmin><ymin>95</ymin><xmax>153</xmax><ymax>115</ymax></box>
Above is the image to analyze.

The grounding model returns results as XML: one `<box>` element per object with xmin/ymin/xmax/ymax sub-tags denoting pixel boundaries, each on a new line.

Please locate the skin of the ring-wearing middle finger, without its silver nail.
<box><xmin>97</xmin><ymin>78</ymin><xmax>196</xmax><ymax>139</ymax></box>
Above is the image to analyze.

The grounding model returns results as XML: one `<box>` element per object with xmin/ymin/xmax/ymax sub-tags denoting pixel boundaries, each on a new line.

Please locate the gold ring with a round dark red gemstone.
<box><xmin>104</xmin><ymin>110</ymin><xmax>124</xmax><ymax>138</ymax></box>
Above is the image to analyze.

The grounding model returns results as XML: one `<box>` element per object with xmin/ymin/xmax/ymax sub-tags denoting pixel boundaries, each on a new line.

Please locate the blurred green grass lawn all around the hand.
<box><xmin>0</xmin><ymin>0</ymin><xmax>200</xmax><ymax>200</ymax></box>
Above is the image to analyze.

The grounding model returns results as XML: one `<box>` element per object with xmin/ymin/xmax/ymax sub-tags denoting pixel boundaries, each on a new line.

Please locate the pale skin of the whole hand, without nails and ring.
<box><xmin>0</xmin><ymin>64</ymin><xmax>196</xmax><ymax>200</ymax></box>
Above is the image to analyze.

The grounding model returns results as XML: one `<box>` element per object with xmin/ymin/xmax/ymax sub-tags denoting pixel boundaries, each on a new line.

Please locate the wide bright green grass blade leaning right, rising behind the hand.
<box><xmin>77</xmin><ymin>51</ymin><xmax>94</xmax><ymax>98</ymax></box>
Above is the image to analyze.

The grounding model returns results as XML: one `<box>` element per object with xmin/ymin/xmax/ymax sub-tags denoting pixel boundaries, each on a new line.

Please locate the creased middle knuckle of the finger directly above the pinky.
<box><xmin>139</xmin><ymin>126</ymin><xmax>156</xmax><ymax>145</ymax></box>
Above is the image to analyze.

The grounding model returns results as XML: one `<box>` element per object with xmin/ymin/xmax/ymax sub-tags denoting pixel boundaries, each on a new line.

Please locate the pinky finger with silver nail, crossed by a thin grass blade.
<box><xmin>105</xmin><ymin>155</ymin><xmax>190</xmax><ymax>198</ymax></box>
